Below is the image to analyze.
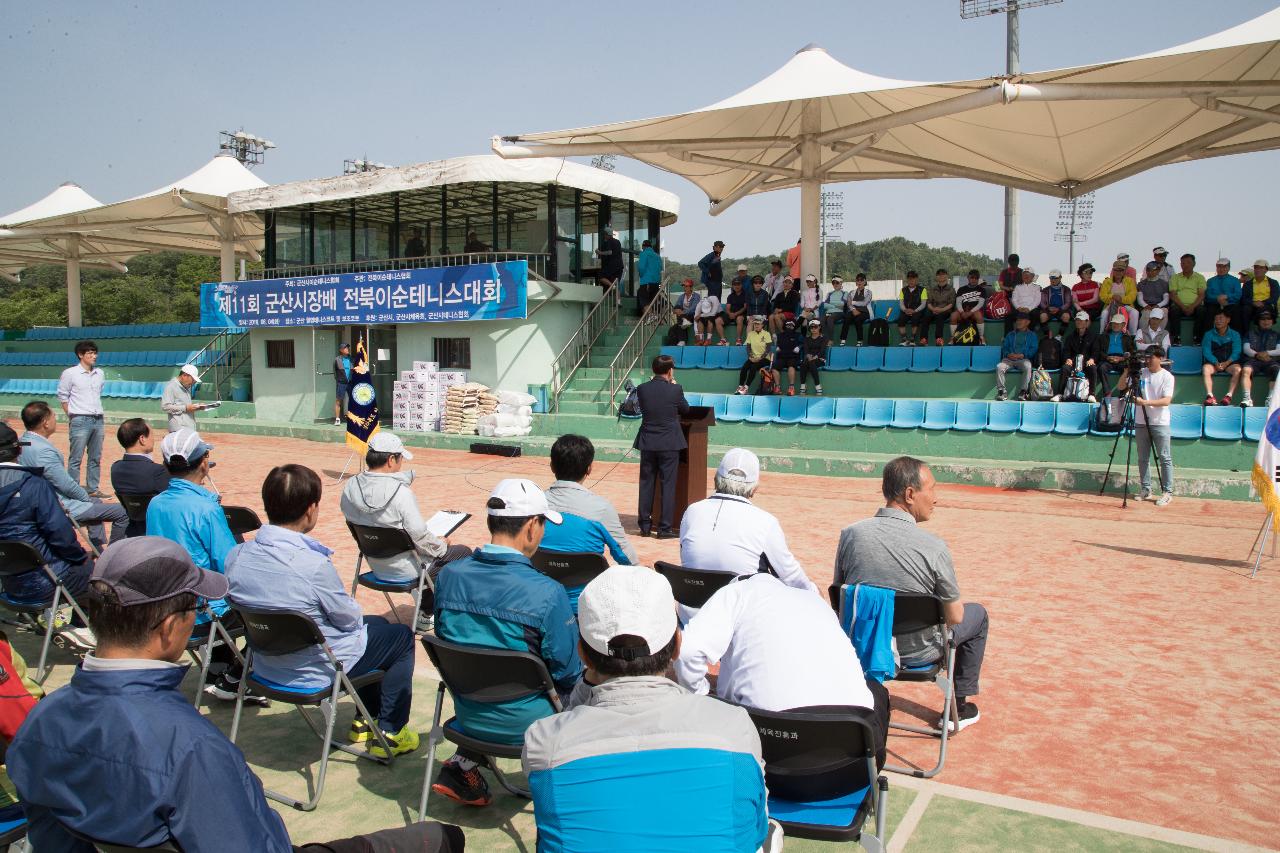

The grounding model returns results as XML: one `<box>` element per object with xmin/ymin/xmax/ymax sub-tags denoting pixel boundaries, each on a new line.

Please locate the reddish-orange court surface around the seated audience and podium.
<box><xmin>42</xmin><ymin>432</ymin><xmax>1280</xmax><ymax>847</ymax></box>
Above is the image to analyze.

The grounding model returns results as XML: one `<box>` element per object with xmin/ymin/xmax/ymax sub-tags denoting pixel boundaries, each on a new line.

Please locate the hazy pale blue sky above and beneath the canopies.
<box><xmin>0</xmin><ymin>0</ymin><xmax>1280</xmax><ymax>269</ymax></box>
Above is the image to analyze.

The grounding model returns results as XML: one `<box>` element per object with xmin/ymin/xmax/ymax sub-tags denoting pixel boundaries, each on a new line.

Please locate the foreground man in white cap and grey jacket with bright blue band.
<box><xmin>521</xmin><ymin>566</ymin><xmax>773</xmax><ymax>850</ymax></box>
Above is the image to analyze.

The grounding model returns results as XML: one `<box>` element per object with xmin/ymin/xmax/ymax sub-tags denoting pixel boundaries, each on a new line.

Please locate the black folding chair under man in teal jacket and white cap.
<box><xmin>417</xmin><ymin>634</ymin><xmax>563</xmax><ymax>821</ymax></box>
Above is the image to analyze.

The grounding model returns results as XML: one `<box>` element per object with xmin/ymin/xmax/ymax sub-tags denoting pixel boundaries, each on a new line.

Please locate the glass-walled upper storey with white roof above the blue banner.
<box><xmin>230</xmin><ymin>155</ymin><xmax>678</xmax><ymax>293</ymax></box>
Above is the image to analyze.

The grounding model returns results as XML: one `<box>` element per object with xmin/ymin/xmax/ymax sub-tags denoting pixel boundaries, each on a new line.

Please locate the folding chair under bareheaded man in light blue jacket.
<box><xmin>230</xmin><ymin>607</ymin><xmax>396</xmax><ymax>812</ymax></box>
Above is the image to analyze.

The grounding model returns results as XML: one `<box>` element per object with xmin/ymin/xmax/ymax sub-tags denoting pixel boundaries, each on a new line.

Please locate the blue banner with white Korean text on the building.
<box><xmin>200</xmin><ymin>260</ymin><xmax>529</xmax><ymax>329</ymax></box>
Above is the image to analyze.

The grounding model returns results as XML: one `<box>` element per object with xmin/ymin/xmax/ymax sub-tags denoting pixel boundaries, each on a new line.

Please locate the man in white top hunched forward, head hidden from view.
<box><xmin>676</xmin><ymin>574</ymin><xmax>888</xmax><ymax>768</ymax></box>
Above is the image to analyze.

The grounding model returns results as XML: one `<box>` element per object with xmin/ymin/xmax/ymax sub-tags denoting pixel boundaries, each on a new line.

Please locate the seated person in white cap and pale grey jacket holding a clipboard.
<box><xmin>338</xmin><ymin>429</ymin><xmax>471</xmax><ymax>630</ymax></box>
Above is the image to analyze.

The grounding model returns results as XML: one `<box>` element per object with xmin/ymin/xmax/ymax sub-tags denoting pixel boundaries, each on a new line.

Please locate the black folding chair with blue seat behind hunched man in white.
<box><xmin>746</xmin><ymin>707</ymin><xmax>888</xmax><ymax>853</ymax></box>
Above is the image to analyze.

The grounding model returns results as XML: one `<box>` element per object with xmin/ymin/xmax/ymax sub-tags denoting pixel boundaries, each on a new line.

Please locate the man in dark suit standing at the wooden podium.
<box><xmin>634</xmin><ymin>356</ymin><xmax>689</xmax><ymax>539</ymax></box>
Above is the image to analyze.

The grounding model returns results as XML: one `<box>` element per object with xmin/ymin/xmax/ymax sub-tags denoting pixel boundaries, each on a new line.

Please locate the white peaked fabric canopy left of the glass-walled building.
<box><xmin>0</xmin><ymin>155</ymin><xmax>266</xmax><ymax>325</ymax></box>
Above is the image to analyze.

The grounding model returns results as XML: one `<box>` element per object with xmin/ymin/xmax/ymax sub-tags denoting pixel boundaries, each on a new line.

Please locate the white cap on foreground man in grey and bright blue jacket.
<box><xmin>577</xmin><ymin>566</ymin><xmax>676</xmax><ymax>660</ymax></box>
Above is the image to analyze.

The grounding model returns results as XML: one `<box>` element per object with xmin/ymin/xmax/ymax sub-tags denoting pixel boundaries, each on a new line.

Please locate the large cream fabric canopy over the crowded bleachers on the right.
<box><xmin>493</xmin><ymin>9</ymin><xmax>1280</xmax><ymax>279</ymax></box>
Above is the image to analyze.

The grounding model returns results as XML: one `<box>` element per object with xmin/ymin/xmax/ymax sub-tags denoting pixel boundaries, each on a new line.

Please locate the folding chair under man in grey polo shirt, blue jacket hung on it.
<box><xmin>827</xmin><ymin>584</ymin><xmax>960</xmax><ymax>779</ymax></box>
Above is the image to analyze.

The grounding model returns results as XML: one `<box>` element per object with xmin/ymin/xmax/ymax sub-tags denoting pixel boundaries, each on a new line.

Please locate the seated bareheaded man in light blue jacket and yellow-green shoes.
<box><xmin>227</xmin><ymin>465</ymin><xmax>419</xmax><ymax>758</ymax></box>
